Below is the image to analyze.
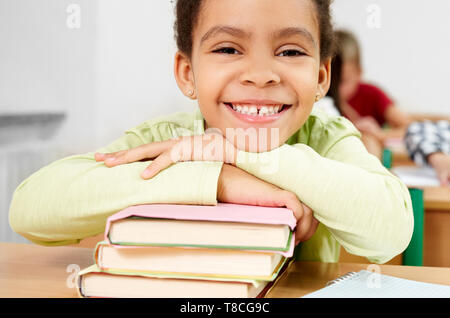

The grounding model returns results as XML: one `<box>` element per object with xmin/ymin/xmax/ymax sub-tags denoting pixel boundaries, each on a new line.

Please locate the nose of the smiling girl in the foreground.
<box><xmin>240</xmin><ymin>59</ymin><xmax>280</xmax><ymax>87</ymax></box>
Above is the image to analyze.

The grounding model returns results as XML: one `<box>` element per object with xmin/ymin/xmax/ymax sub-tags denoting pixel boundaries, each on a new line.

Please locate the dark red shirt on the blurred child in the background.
<box><xmin>348</xmin><ymin>83</ymin><xmax>393</xmax><ymax>126</ymax></box>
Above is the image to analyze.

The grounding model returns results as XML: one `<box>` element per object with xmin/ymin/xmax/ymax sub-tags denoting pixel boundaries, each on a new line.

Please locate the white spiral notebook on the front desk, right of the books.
<box><xmin>303</xmin><ymin>270</ymin><xmax>450</xmax><ymax>298</ymax></box>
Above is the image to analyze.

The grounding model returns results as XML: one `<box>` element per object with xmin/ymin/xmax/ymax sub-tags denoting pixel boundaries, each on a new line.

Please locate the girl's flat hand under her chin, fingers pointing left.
<box><xmin>95</xmin><ymin>131</ymin><xmax>237</xmax><ymax>179</ymax></box>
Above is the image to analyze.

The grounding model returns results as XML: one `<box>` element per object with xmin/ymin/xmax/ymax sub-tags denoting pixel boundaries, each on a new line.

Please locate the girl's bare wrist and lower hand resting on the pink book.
<box><xmin>217</xmin><ymin>164</ymin><xmax>319</xmax><ymax>245</ymax></box>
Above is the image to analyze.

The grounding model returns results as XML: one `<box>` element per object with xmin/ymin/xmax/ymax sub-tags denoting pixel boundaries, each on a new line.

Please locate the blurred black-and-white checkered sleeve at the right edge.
<box><xmin>405</xmin><ymin>120</ymin><xmax>450</xmax><ymax>166</ymax></box>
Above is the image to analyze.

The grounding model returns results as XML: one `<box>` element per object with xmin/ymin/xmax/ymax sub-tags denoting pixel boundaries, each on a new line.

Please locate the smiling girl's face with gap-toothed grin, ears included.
<box><xmin>175</xmin><ymin>0</ymin><xmax>330</xmax><ymax>151</ymax></box>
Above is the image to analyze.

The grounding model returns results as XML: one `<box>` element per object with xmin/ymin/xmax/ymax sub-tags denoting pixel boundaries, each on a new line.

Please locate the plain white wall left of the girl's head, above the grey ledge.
<box><xmin>0</xmin><ymin>0</ymin><xmax>195</xmax><ymax>153</ymax></box>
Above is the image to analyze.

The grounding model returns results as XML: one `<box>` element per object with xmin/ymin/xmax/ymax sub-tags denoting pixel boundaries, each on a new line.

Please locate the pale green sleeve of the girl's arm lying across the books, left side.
<box><xmin>9</xmin><ymin>125</ymin><xmax>222</xmax><ymax>245</ymax></box>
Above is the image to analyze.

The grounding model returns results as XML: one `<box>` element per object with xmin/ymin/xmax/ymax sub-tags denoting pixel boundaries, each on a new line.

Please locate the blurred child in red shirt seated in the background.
<box><xmin>330</xmin><ymin>30</ymin><xmax>411</xmax><ymax>158</ymax></box>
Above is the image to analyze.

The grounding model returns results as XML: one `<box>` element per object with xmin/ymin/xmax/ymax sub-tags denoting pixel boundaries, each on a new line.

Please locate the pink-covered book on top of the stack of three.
<box><xmin>105</xmin><ymin>203</ymin><xmax>297</xmax><ymax>257</ymax></box>
